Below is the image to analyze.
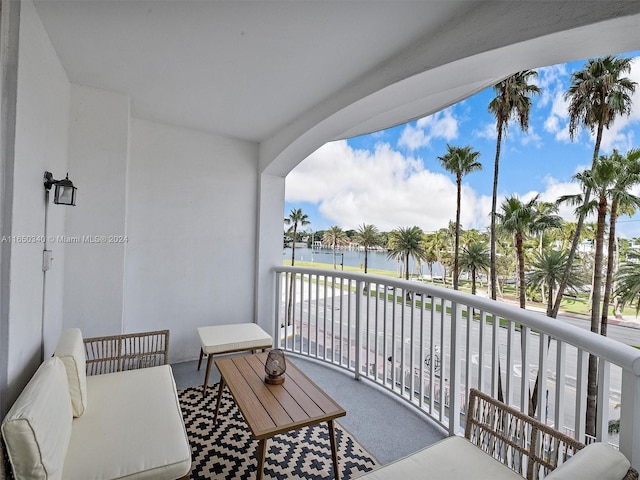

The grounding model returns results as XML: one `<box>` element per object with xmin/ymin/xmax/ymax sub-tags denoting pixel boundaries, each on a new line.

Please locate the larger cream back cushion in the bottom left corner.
<box><xmin>2</xmin><ymin>357</ymin><xmax>73</xmax><ymax>480</ymax></box>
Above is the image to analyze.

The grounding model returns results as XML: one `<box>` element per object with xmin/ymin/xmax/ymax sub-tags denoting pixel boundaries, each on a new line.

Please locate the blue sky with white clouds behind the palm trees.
<box><xmin>284</xmin><ymin>51</ymin><xmax>640</xmax><ymax>238</ymax></box>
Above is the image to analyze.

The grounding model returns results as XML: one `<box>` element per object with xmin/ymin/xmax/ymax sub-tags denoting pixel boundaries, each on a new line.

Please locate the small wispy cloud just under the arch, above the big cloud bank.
<box><xmin>398</xmin><ymin>108</ymin><xmax>458</xmax><ymax>151</ymax></box>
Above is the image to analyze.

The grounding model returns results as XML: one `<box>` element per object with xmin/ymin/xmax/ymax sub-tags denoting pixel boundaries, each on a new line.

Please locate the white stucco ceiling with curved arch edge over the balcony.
<box><xmin>35</xmin><ymin>0</ymin><xmax>640</xmax><ymax>172</ymax></box>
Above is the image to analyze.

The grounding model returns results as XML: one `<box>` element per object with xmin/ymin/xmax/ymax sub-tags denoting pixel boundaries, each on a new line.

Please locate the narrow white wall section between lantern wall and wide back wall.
<box><xmin>64</xmin><ymin>85</ymin><xmax>130</xmax><ymax>337</ymax></box>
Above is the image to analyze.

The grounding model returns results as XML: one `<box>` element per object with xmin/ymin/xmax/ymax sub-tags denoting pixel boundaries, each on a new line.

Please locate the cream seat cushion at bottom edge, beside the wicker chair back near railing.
<box><xmin>359</xmin><ymin>437</ymin><xmax>522</xmax><ymax>480</ymax></box>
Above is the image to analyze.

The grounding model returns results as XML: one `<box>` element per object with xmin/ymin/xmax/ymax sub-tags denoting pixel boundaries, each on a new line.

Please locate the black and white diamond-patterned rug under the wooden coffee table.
<box><xmin>178</xmin><ymin>385</ymin><xmax>379</xmax><ymax>480</ymax></box>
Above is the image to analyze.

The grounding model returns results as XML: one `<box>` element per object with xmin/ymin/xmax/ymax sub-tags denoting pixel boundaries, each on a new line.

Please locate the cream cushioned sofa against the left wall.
<box><xmin>2</xmin><ymin>329</ymin><xmax>191</xmax><ymax>480</ymax></box>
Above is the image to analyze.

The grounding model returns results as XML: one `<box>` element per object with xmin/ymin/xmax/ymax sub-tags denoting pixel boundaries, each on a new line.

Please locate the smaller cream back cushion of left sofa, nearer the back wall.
<box><xmin>55</xmin><ymin>328</ymin><xmax>87</xmax><ymax>417</ymax></box>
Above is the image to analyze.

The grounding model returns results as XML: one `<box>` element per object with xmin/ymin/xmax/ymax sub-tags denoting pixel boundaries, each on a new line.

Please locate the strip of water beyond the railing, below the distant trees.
<box><xmin>282</xmin><ymin>247</ymin><xmax>442</xmax><ymax>276</ymax></box>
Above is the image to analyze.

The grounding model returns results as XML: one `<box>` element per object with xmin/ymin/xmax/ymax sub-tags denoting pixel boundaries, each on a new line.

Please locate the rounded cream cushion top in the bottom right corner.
<box><xmin>545</xmin><ymin>442</ymin><xmax>631</xmax><ymax>480</ymax></box>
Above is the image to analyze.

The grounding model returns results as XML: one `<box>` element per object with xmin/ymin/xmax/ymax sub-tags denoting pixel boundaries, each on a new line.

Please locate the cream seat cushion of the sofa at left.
<box><xmin>62</xmin><ymin>365</ymin><xmax>191</xmax><ymax>480</ymax></box>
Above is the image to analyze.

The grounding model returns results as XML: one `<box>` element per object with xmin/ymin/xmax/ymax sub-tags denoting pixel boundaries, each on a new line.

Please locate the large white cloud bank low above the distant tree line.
<box><xmin>286</xmin><ymin>140</ymin><xmax>491</xmax><ymax>231</ymax></box>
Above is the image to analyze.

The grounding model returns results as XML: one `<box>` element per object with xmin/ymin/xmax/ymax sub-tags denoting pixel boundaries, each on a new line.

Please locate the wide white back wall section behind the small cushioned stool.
<box><xmin>124</xmin><ymin>120</ymin><xmax>258</xmax><ymax>362</ymax></box>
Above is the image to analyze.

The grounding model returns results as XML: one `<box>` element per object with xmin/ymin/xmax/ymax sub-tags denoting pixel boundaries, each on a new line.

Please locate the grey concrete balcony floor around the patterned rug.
<box><xmin>172</xmin><ymin>355</ymin><xmax>446</xmax><ymax>465</ymax></box>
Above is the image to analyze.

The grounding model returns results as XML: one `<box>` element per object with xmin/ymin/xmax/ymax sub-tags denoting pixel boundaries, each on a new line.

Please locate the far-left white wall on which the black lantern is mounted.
<box><xmin>5</xmin><ymin>1</ymin><xmax>70</xmax><ymax>397</ymax></box>
